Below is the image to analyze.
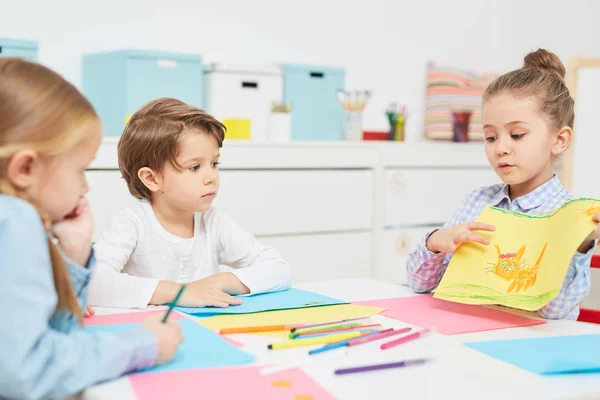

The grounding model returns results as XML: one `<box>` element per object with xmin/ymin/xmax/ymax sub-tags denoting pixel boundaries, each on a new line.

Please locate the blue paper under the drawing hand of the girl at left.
<box><xmin>82</xmin><ymin>320</ymin><xmax>254</xmax><ymax>372</ymax></box>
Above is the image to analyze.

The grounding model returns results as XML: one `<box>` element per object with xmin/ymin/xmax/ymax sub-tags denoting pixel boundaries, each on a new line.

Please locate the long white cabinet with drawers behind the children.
<box><xmin>87</xmin><ymin>139</ymin><xmax>498</xmax><ymax>284</ymax></box>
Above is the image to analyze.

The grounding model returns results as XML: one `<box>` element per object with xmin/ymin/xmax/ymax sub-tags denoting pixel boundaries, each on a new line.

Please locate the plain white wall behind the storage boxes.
<box><xmin>0</xmin><ymin>0</ymin><xmax>600</xmax><ymax>140</ymax></box>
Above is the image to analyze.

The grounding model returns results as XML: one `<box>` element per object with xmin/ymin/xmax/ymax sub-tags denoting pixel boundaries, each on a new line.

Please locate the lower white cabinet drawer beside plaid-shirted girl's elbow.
<box><xmin>380</xmin><ymin>227</ymin><xmax>433</xmax><ymax>285</ymax></box>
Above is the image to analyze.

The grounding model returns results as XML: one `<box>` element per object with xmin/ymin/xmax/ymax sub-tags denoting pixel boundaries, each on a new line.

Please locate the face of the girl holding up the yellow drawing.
<box><xmin>483</xmin><ymin>93</ymin><xmax>571</xmax><ymax>198</ymax></box>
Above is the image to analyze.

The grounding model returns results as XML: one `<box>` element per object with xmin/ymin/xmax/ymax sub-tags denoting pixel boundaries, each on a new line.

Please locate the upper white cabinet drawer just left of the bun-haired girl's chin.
<box><xmin>385</xmin><ymin>168</ymin><xmax>500</xmax><ymax>226</ymax></box>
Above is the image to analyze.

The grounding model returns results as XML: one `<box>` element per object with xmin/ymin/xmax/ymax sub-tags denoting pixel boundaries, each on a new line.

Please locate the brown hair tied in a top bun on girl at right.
<box><xmin>483</xmin><ymin>49</ymin><xmax>575</xmax><ymax>129</ymax></box>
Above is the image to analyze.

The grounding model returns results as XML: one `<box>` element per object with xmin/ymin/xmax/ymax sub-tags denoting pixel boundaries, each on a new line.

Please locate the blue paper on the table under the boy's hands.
<box><xmin>176</xmin><ymin>289</ymin><xmax>346</xmax><ymax>315</ymax></box>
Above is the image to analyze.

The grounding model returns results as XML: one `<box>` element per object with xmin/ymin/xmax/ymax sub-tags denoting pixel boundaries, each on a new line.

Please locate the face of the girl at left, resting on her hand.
<box><xmin>19</xmin><ymin>122</ymin><xmax>102</xmax><ymax>222</ymax></box>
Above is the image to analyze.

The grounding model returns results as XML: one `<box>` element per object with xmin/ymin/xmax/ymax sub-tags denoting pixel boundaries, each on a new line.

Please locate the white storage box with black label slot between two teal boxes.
<box><xmin>204</xmin><ymin>64</ymin><xmax>283</xmax><ymax>142</ymax></box>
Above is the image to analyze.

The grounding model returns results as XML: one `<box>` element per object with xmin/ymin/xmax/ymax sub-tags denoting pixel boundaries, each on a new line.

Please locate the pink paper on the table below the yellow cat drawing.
<box><xmin>354</xmin><ymin>295</ymin><xmax>545</xmax><ymax>335</ymax></box>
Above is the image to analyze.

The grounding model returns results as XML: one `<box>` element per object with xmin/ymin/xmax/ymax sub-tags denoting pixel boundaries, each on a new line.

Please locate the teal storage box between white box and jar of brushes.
<box><xmin>282</xmin><ymin>64</ymin><xmax>346</xmax><ymax>140</ymax></box>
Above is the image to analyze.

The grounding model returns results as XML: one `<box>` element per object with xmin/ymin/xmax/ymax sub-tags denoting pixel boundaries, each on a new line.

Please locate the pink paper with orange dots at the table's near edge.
<box><xmin>129</xmin><ymin>367</ymin><xmax>335</xmax><ymax>400</ymax></box>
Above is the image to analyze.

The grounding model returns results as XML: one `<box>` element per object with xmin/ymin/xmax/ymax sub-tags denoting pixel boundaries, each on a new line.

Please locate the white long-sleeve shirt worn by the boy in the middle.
<box><xmin>89</xmin><ymin>200</ymin><xmax>291</xmax><ymax>308</ymax></box>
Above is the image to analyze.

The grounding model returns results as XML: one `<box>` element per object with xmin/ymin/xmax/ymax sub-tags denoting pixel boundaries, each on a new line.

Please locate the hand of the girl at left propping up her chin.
<box><xmin>52</xmin><ymin>196</ymin><xmax>94</xmax><ymax>266</ymax></box>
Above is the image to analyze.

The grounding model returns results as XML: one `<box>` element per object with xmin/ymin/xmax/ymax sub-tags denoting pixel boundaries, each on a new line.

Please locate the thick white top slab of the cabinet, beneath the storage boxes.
<box><xmin>90</xmin><ymin>138</ymin><xmax>488</xmax><ymax>170</ymax></box>
